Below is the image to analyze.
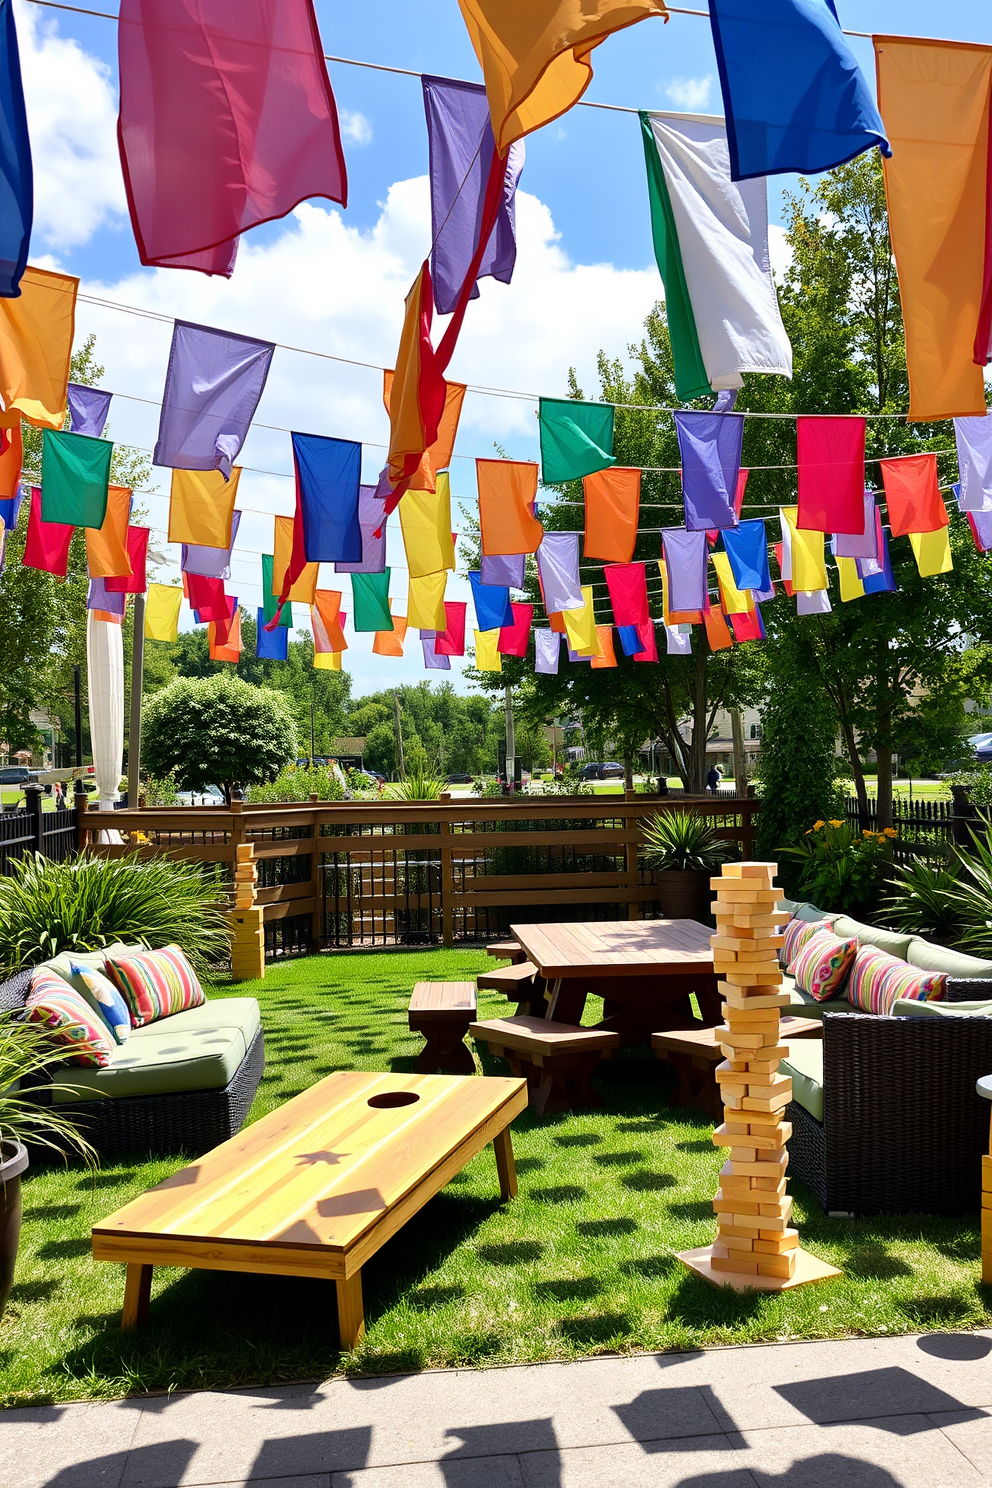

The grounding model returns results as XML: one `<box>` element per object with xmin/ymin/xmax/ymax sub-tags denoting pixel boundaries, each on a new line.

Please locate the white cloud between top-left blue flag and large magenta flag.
<box><xmin>16</xmin><ymin>3</ymin><xmax>126</xmax><ymax>247</ymax></box>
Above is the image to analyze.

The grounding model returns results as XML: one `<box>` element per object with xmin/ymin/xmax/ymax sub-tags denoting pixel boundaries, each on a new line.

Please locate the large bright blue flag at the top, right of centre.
<box><xmin>709</xmin><ymin>0</ymin><xmax>892</xmax><ymax>182</ymax></box>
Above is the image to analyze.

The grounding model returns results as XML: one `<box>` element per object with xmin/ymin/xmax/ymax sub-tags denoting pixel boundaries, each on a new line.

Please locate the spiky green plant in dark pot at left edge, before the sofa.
<box><xmin>0</xmin><ymin>1013</ymin><xmax>95</xmax><ymax>1318</ymax></box>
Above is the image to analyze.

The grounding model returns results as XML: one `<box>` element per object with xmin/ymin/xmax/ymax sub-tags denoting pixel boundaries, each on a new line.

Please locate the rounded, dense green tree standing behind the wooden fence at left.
<box><xmin>141</xmin><ymin>676</ymin><xmax>296</xmax><ymax>801</ymax></box>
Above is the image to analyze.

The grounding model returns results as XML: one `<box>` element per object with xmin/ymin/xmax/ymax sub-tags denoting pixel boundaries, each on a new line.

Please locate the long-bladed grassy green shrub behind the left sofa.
<box><xmin>0</xmin><ymin>853</ymin><xmax>229</xmax><ymax>976</ymax></box>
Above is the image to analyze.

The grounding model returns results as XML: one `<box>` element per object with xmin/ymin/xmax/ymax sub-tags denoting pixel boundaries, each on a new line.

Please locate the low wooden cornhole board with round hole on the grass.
<box><xmin>92</xmin><ymin>1070</ymin><xmax>526</xmax><ymax>1348</ymax></box>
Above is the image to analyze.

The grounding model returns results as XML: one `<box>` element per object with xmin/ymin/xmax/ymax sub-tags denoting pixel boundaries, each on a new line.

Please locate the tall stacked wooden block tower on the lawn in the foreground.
<box><xmin>678</xmin><ymin>863</ymin><xmax>840</xmax><ymax>1292</ymax></box>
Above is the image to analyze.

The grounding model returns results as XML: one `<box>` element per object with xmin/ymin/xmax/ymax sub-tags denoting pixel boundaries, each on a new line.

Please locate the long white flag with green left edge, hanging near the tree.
<box><xmin>641</xmin><ymin>113</ymin><xmax>793</xmax><ymax>402</ymax></box>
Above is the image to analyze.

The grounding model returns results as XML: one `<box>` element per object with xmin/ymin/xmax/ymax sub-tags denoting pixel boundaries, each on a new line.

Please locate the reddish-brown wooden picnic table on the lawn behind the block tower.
<box><xmin>510</xmin><ymin>920</ymin><xmax>720</xmax><ymax>1045</ymax></box>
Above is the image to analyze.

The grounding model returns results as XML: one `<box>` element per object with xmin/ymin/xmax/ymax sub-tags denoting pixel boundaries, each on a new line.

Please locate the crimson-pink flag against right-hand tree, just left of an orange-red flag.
<box><xmin>796</xmin><ymin>418</ymin><xmax>866</xmax><ymax>536</ymax></box>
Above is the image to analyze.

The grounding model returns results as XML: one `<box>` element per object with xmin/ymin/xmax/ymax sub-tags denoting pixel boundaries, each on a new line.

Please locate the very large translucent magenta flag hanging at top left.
<box><xmin>117</xmin><ymin>0</ymin><xmax>348</xmax><ymax>278</ymax></box>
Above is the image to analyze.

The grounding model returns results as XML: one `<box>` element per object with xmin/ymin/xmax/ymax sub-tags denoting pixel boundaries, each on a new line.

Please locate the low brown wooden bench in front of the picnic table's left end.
<box><xmin>468</xmin><ymin>1015</ymin><xmax>620</xmax><ymax>1116</ymax></box>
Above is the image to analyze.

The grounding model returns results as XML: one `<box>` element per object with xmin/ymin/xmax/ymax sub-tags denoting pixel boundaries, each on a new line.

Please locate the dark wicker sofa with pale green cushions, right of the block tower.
<box><xmin>782</xmin><ymin>905</ymin><xmax>992</xmax><ymax>1214</ymax></box>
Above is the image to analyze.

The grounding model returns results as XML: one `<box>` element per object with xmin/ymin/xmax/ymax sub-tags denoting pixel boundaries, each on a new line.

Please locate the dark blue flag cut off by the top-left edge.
<box><xmin>0</xmin><ymin>0</ymin><xmax>34</xmax><ymax>299</ymax></box>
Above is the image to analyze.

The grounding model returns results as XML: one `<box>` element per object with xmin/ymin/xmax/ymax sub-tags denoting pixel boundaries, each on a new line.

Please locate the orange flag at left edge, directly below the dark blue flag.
<box><xmin>0</xmin><ymin>268</ymin><xmax>79</xmax><ymax>429</ymax></box>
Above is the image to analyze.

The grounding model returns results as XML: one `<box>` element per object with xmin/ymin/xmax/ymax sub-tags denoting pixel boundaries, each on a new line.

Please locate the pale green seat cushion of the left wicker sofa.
<box><xmin>52</xmin><ymin>997</ymin><xmax>260</xmax><ymax>1106</ymax></box>
